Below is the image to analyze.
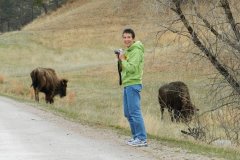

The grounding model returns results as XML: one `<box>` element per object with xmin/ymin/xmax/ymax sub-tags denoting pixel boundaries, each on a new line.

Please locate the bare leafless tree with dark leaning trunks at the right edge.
<box><xmin>157</xmin><ymin>0</ymin><xmax>240</xmax><ymax>108</ymax></box>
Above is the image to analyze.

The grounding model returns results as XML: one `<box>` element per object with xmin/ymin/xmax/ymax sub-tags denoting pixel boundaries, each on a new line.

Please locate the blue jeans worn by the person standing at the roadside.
<box><xmin>123</xmin><ymin>84</ymin><xmax>147</xmax><ymax>140</ymax></box>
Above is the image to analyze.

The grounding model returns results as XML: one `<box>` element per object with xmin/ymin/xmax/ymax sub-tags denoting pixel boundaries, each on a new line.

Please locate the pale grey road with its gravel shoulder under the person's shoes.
<box><xmin>0</xmin><ymin>97</ymin><xmax>223</xmax><ymax>160</ymax></box>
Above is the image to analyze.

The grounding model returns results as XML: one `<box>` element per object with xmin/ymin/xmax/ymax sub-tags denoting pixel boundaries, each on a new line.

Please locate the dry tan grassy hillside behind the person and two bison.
<box><xmin>0</xmin><ymin>0</ymin><xmax>238</xmax><ymax>158</ymax></box>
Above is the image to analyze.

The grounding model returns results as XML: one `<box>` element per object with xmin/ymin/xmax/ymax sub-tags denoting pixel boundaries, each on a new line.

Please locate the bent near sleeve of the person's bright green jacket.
<box><xmin>122</xmin><ymin>49</ymin><xmax>143</xmax><ymax>73</ymax></box>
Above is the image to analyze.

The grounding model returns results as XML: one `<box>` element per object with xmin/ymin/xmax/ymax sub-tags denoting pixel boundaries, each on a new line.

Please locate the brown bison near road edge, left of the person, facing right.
<box><xmin>30</xmin><ymin>68</ymin><xmax>68</xmax><ymax>104</ymax></box>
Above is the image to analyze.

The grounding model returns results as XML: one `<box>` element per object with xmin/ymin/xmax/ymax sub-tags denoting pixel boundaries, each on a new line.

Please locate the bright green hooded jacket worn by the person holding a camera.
<box><xmin>121</xmin><ymin>41</ymin><xmax>144</xmax><ymax>87</ymax></box>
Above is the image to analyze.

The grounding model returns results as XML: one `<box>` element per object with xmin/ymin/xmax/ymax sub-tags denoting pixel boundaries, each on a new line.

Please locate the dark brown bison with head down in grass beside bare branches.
<box><xmin>158</xmin><ymin>81</ymin><xmax>198</xmax><ymax>122</ymax></box>
